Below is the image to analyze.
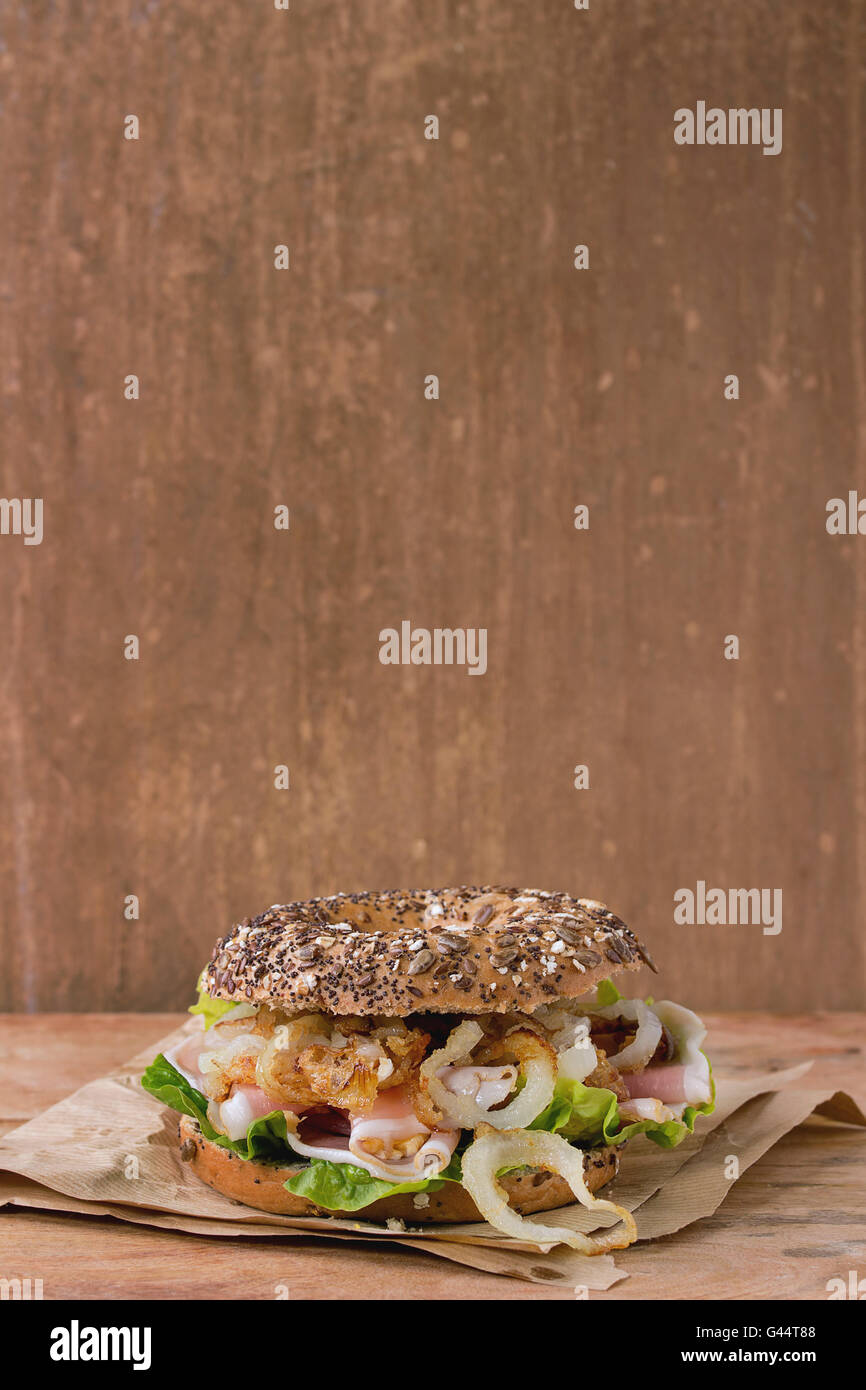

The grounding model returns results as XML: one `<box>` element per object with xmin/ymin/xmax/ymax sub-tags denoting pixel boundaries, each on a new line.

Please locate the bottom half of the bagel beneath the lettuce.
<box><xmin>178</xmin><ymin>1115</ymin><xmax>620</xmax><ymax>1226</ymax></box>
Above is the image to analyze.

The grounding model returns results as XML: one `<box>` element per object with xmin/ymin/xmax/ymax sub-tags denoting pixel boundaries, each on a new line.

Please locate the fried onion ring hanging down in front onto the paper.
<box><xmin>461</xmin><ymin>1130</ymin><xmax>638</xmax><ymax>1255</ymax></box>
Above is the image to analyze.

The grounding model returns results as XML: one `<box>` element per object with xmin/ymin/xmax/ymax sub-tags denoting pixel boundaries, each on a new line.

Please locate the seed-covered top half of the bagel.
<box><xmin>203</xmin><ymin>887</ymin><xmax>656</xmax><ymax>1017</ymax></box>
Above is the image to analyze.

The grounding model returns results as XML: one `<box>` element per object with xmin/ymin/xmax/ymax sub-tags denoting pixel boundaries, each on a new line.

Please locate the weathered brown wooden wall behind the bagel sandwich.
<box><xmin>0</xmin><ymin>0</ymin><xmax>866</xmax><ymax>1011</ymax></box>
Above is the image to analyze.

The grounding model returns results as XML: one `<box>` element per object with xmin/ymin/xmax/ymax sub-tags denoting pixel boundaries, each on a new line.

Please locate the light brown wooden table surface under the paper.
<box><xmin>0</xmin><ymin>1013</ymin><xmax>866</xmax><ymax>1300</ymax></box>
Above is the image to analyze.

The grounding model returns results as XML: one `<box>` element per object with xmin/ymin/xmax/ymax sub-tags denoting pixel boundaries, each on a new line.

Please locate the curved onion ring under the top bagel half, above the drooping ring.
<box><xmin>420</xmin><ymin>1019</ymin><xmax>556</xmax><ymax>1130</ymax></box>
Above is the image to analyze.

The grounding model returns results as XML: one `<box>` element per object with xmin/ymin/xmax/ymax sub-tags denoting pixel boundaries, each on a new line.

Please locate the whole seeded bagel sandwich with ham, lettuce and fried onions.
<box><xmin>142</xmin><ymin>887</ymin><xmax>713</xmax><ymax>1254</ymax></box>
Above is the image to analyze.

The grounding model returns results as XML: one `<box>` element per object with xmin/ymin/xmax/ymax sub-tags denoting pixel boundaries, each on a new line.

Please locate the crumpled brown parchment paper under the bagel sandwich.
<box><xmin>0</xmin><ymin>1024</ymin><xmax>866</xmax><ymax>1290</ymax></box>
